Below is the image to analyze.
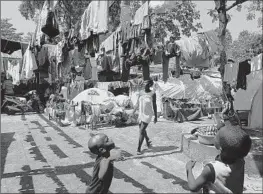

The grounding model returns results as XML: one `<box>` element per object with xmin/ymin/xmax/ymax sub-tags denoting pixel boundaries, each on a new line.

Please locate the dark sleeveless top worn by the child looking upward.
<box><xmin>86</xmin><ymin>156</ymin><xmax>113</xmax><ymax>193</ymax></box>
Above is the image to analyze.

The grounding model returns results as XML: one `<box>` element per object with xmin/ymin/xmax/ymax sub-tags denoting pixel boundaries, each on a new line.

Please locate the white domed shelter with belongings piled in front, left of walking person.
<box><xmin>66</xmin><ymin>88</ymin><xmax>137</xmax><ymax>129</ymax></box>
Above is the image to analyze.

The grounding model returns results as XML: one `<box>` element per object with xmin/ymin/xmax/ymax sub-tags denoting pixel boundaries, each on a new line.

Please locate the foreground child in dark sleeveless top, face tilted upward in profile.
<box><xmin>86</xmin><ymin>134</ymin><xmax>121</xmax><ymax>194</ymax></box>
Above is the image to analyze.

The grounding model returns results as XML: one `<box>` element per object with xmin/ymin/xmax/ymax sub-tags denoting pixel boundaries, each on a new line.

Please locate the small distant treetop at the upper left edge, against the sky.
<box><xmin>1</xmin><ymin>18</ymin><xmax>23</xmax><ymax>41</ymax></box>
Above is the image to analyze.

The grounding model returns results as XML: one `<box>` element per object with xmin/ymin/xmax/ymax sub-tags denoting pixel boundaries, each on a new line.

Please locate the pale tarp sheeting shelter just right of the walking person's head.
<box><xmin>157</xmin><ymin>75</ymin><xmax>222</xmax><ymax>100</ymax></box>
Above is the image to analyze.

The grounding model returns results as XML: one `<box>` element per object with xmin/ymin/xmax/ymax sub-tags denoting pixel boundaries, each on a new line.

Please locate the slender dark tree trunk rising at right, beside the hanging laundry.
<box><xmin>214</xmin><ymin>0</ymin><xmax>228</xmax><ymax>100</ymax></box>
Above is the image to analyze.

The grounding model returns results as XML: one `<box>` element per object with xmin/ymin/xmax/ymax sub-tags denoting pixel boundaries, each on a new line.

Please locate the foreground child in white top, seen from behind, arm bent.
<box><xmin>186</xmin><ymin>126</ymin><xmax>251</xmax><ymax>193</ymax></box>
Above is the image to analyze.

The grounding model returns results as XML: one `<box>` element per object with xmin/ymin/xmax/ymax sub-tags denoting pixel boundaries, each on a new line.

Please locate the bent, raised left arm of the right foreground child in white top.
<box><xmin>186</xmin><ymin>161</ymin><xmax>215</xmax><ymax>192</ymax></box>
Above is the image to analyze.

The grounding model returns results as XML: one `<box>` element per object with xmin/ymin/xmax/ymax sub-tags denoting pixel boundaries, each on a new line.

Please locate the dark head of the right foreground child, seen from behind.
<box><xmin>215</xmin><ymin>126</ymin><xmax>251</xmax><ymax>164</ymax></box>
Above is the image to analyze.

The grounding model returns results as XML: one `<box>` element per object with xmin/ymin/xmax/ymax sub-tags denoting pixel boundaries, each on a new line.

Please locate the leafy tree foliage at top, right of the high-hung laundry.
<box><xmin>151</xmin><ymin>1</ymin><xmax>202</xmax><ymax>43</ymax></box>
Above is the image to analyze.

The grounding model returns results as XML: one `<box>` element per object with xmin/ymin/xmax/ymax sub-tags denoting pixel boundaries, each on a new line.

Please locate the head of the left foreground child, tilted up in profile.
<box><xmin>88</xmin><ymin>133</ymin><xmax>115</xmax><ymax>155</ymax></box>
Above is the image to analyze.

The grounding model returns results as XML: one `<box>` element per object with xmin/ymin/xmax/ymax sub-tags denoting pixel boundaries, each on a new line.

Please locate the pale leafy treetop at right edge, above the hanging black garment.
<box><xmin>229</xmin><ymin>30</ymin><xmax>263</xmax><ymax>61</ymax></box>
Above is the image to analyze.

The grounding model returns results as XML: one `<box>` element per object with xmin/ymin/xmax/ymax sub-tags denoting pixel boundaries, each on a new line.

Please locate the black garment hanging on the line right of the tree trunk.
<box><xmin>236</xmin><ymin>59</ymin><xmax>251</xmax><ymax>90</ymax></box>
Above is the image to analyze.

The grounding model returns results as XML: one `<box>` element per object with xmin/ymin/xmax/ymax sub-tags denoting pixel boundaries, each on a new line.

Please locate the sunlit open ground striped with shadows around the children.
<box><xmin>1</xmin><ymin>114</ymin><xmax>262</xmax><ymax>193</ymax></box>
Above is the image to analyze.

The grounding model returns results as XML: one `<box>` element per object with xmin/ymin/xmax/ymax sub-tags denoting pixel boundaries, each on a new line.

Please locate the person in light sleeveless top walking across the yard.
<box><xmin>133</xmin><ymin>80</ymin><xmax>157</xmax><ymax>155</ymax></box>
